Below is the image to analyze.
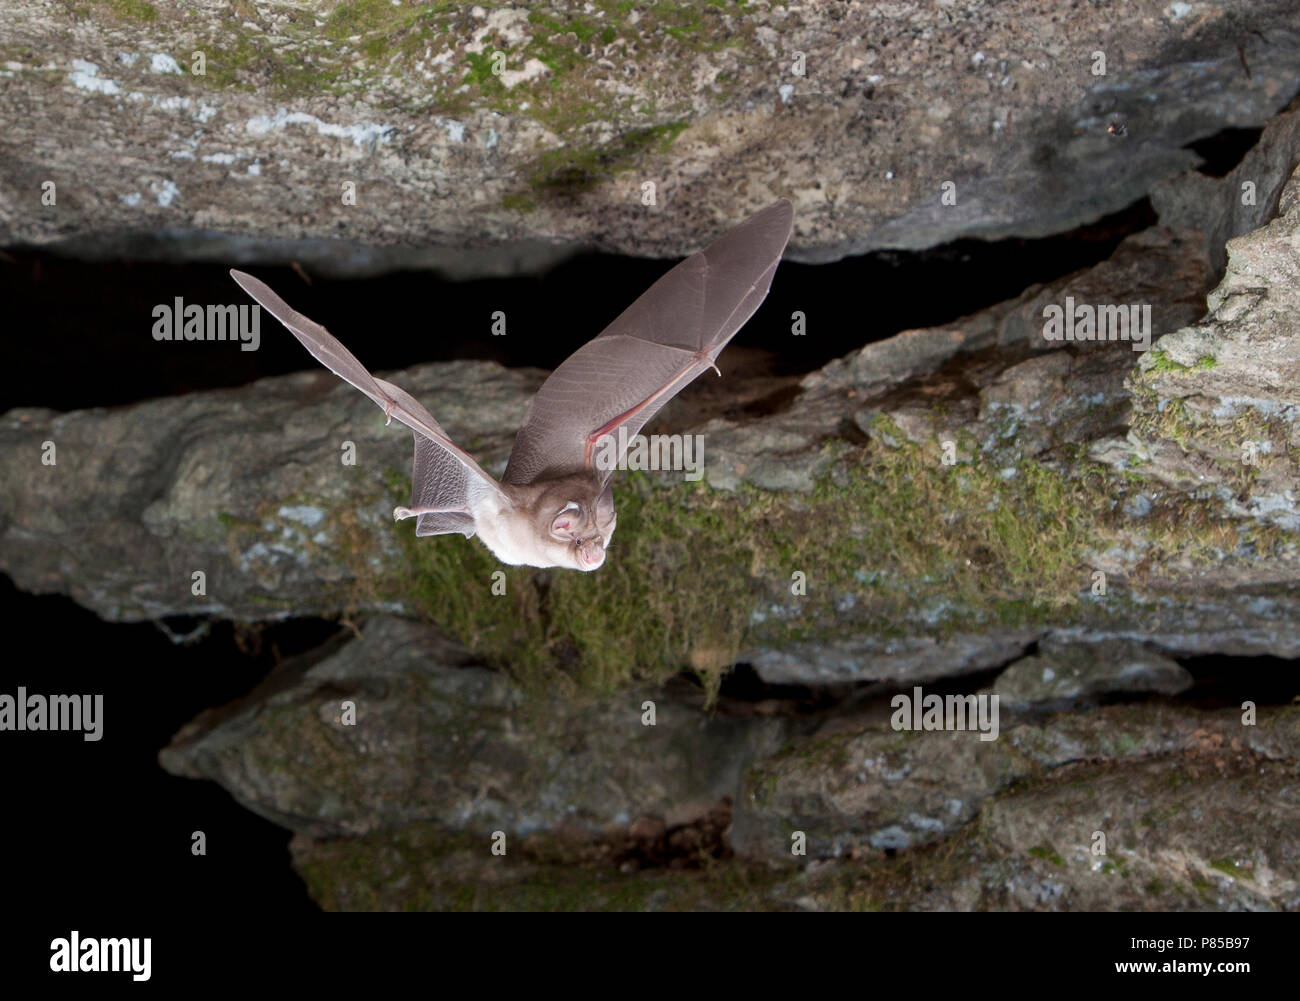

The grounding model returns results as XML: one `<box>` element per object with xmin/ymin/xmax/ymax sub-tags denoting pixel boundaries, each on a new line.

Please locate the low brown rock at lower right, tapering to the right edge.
<box><xmin>732</xmin><ymin>685</ymin><xmax>1297</xmax><ymax>863</ymax></box>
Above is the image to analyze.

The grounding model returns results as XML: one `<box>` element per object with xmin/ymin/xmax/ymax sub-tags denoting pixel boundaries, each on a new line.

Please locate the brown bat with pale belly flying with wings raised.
<box><xmin>230</xmin><ymin>199</ymin><xmax>794</xmax><ymax>571</ymax></box>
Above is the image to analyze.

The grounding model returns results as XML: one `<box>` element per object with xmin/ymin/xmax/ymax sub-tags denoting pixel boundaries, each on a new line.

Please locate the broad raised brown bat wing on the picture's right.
<box><xmin>502</xmin><ymin>199</ymin><xmax>794</xmax><ymax>484</ymax></box>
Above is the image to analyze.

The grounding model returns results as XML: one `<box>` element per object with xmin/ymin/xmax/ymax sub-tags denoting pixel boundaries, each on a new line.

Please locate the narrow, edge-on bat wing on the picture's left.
<box><xmin>230</xmin><ymin>270</ymin><xmax>504</xmax><ymax>537</ymax></box>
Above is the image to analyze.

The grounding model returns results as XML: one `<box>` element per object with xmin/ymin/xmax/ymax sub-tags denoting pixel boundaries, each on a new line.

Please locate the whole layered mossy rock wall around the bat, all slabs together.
<box><xmin>10</xmin><ymin>9</ymin><xmax>1300</xmax><ymax>910</ymax></box>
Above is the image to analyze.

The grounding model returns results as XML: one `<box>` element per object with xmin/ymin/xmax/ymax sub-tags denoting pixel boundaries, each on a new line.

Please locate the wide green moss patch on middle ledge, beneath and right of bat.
<box><xmin>369</xmin><ymin>416</ymin><xmax>1118</xmax><ymax>692</ymax></box>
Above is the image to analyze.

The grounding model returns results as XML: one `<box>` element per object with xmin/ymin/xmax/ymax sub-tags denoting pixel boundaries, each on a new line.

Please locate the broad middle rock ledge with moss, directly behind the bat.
<box><xmin>0</xmin><ymin>114</ymin><xmax>1300</xmax><ymax>689</ymax></box>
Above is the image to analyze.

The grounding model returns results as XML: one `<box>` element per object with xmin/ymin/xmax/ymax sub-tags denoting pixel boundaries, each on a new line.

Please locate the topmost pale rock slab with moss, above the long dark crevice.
<box><xmin>0</xmin><ymin>0</ymin><xmax>1300</xmax><ymax>274</ymax></box>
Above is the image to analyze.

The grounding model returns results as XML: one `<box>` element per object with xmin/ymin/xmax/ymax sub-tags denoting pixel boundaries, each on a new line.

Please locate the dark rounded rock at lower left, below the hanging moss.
<box><xmin>161</xmin><ymin>619</ymin><xmax>772</xmax><ymax>837</ymax></box>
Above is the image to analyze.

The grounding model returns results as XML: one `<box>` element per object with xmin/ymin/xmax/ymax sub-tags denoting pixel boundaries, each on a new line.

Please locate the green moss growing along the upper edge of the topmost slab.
<box><xmin>78</xmin><ymin>0</ymin><xmax>766</xmax><ymax>138</ymax></box>
